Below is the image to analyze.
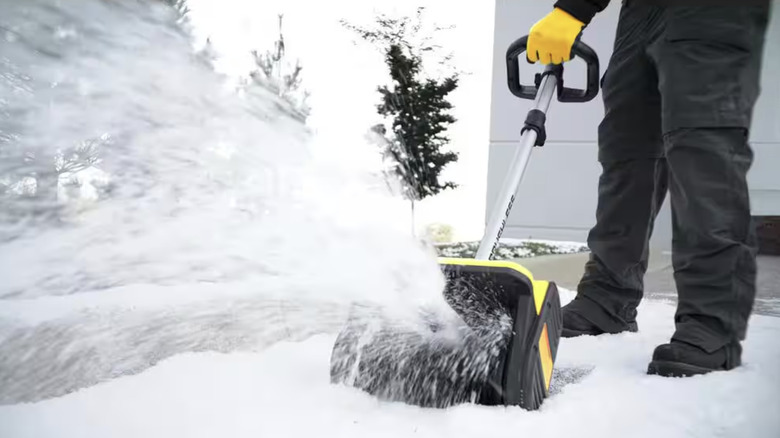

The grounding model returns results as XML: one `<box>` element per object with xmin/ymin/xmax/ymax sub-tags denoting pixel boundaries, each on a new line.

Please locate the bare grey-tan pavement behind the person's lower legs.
<box><xmin>517</xmin><ymin>252</ymin><xmax>780</xmax><ymax>317</ymax></box>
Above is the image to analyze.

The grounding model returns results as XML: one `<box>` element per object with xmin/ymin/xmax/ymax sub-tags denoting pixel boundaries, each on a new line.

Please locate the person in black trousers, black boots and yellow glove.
<box><xmin>526</xmin><ymin>0</ymin><xmax>770</xmax><ymax>376</ymax></box>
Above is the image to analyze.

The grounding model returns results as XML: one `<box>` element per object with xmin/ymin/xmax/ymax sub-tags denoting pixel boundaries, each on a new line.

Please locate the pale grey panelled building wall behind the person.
<box><xmin>486</xmin><ymin>0</ymin><xmax>780</xmax><ymax>249</ymax></box>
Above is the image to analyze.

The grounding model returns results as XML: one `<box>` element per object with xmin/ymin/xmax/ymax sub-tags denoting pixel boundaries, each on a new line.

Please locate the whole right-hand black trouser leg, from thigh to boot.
<box><xmin>651</xmin><ymin>6</ymin><xmax>768</xmax><ymax>352</ymax></box>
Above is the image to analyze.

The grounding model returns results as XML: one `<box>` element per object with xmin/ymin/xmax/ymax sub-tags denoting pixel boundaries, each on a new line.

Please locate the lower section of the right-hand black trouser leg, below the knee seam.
<box><xmin>666</xmin><ymin>128</ymin><xmax>756</xmax><ymax>352</ymax></box>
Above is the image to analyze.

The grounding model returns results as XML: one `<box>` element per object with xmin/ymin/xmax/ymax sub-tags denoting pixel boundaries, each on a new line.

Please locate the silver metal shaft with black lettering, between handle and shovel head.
<box><xmin>475</xmin><ymin>75</ymin><xmax>556</xmax><ymax>260</ymax></box>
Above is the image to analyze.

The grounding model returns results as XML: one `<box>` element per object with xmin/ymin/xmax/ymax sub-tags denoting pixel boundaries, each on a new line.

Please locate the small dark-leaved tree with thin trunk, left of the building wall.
<box><xmin>342</xmin><ymin>7</ymin><xmax>458</xmax><ymax>220</ymax></box>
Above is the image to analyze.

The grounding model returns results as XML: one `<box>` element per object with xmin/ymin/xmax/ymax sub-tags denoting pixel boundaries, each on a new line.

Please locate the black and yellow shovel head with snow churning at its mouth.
<box><xmin>331</xmin><ymin>259</ymin><xmax>560</xmax><ymax>409</ymax></box>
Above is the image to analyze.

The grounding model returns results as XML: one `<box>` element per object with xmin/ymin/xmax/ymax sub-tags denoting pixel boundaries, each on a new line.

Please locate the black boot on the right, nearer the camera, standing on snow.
<box><xmin>647</xmin><ymin>340</ymin><xmax>742</xmax><ymax>377</ymax></box>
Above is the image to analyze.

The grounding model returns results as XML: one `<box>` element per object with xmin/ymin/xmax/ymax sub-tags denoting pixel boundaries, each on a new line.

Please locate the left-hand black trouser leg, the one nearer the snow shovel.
<box><xmin>564</xmin><ymin>5</ymin><xmax>667</xmax><ymax>333</ymax></box>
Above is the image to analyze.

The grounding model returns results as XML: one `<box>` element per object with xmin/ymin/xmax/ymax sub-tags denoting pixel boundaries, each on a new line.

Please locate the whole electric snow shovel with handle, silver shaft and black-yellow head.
<box><xmin>330</xmin><ymin>37</ymin><xmax>599</xmax><ymax>410</ymax></box>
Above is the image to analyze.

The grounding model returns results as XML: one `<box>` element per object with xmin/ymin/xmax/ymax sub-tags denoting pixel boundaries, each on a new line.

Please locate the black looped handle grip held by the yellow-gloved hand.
<box><xmin>506</xmin><ymin>35</ymin><xmax>599</xmax><ymax>102</ymax></box>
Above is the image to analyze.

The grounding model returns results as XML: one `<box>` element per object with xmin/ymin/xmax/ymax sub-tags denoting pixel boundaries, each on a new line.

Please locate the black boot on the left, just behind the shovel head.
<box><xmin>561</xmin><ymin>296</ymin><xmax>638</xmax><ymax>338</ymax></box>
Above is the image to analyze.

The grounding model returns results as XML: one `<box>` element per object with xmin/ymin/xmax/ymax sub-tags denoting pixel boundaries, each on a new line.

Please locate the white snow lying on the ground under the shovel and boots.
<box><xmin>0</xmin><ymin>290</ymin><xmax>780</xmax><ymax>438</ymax></box>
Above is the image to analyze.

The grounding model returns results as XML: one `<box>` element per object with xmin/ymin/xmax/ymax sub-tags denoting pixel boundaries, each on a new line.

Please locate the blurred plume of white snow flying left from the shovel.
<box><xmin>0</xmin><ymin>0</ymin><xmax>450</xmax><ymax>403</ymax></box>
